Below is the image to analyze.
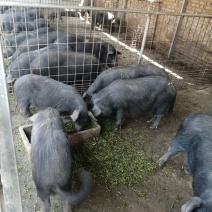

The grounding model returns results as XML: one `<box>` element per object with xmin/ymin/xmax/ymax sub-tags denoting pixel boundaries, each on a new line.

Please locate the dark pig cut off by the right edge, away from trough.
<box><xmin>159</xmin><ymin>113</ymin><xmax>212</xmax><ymax>212</ymax></box>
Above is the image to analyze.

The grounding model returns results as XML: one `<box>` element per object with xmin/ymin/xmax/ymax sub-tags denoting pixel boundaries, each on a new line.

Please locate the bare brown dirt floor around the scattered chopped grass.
<box><xmin>12</xmin><ymin>82</ymin><xmax>212</xmax><ymax>212</ymax></box>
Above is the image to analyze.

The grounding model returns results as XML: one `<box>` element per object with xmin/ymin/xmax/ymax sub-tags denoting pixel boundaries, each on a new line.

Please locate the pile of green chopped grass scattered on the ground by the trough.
<box><xmin>74</xmin><ymin>119</ymin><xmax>156</xmax><ymax>189</ymax></box>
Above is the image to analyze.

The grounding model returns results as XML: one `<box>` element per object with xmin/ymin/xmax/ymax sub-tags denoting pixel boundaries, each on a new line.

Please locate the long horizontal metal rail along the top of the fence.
<box><xmin>0</xmin><ymin>1</ymin><xmax>212</xmax><ymax>18</ymax></box>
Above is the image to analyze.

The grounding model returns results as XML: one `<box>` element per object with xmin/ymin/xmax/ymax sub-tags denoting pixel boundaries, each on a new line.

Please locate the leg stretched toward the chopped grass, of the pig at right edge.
<box><xmin>159</xmin><ymin>139</ymin><xmax>185</xmax><ymax>167</ymax></box>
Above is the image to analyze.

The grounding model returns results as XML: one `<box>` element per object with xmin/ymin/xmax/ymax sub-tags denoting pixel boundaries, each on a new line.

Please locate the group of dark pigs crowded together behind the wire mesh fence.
<box><xmin>1</xmin><ymin>8</ymin><xmax>120</xmax><ymax>84</ymax></box>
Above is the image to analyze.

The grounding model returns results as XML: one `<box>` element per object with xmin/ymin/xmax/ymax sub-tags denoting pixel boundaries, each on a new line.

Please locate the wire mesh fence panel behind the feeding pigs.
<box><xmin>1</xmin><ymin>1</ymin><xmax>211</xmax><ymax>96</ymax></box>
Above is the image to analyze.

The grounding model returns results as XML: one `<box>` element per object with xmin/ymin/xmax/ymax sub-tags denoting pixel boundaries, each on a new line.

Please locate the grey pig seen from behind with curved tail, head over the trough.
<box><xmin>29</xmin><ymin>108</ymin><xmax>92</xmax><ymax>212</ymax></box>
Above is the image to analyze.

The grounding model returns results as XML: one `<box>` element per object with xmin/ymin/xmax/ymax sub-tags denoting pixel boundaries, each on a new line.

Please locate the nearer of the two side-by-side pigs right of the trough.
<box><xmin>91</xmin><ymin>76</ymin><xmax>176</xmax><ymax>129</ymax></box>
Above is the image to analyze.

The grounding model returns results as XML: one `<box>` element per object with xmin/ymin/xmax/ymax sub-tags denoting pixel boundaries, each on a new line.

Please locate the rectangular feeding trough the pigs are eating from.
<box><xmin>19</xmin><ymin>116</ymin><xmax>101</xmax><ymax>155</ymax></box>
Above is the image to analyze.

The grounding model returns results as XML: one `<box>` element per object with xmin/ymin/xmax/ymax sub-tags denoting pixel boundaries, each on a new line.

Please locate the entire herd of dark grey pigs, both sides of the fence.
<box><xmin>1</xmin><ymin>4</ymin><xmax>212</xmax><ymax>212</ymax></box>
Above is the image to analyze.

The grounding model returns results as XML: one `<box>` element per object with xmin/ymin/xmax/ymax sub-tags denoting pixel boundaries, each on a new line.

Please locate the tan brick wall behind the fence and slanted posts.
<box><xmin>92</xmin><ymin>0</ymin><xmax>212</xmax><ymax>66</ymax></box>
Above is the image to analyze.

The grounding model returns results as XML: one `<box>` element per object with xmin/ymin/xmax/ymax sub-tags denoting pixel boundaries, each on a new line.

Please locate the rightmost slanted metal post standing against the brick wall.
<box><xmin>168</xmin><ymin>0</ymin><xmax>188</xmax><ymax>59</ymax></box>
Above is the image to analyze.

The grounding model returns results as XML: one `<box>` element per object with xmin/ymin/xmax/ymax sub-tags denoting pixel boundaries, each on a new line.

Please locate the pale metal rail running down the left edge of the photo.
<box><xmin>0</xmin><ymin>38</ymin><xmax>22</xmax><ymax>212</ymax></box>
